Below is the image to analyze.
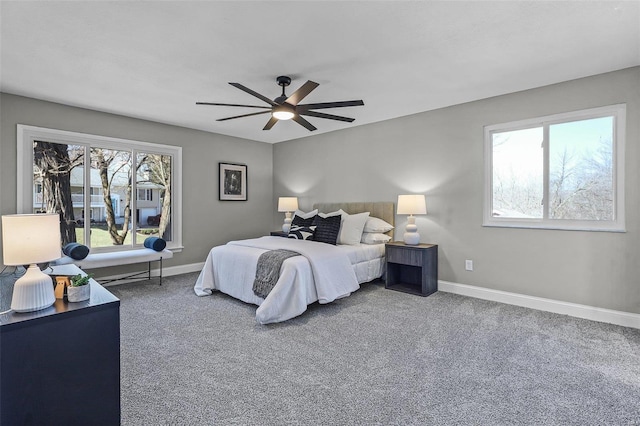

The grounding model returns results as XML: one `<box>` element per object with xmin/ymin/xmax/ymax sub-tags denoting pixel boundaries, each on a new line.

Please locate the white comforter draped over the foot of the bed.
<box><xmin>194</xmin><ymin>237</ymin><xmax>360</xmax><ymax>324</ymax></box>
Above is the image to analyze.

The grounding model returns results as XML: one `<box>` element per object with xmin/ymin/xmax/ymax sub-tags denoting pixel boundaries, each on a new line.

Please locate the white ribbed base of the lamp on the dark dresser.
<box><xmin>11</xmin><ymin>264</ymin><xmax>56</xmax><ymax>312</ymax></box>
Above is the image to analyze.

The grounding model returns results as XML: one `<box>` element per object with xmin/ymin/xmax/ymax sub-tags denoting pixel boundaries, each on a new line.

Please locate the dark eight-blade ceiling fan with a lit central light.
<box><xmin>196</xmin><ymin>75</ymin><xmax>364</xmax><ymax>131</ymax></box>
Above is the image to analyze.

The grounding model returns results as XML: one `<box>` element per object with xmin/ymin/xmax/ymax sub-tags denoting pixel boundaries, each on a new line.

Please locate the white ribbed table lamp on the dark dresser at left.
<box><xmin>2</xmin><ymin>214</ymin><xmax>62</xmax><ymax>312</ymax></box>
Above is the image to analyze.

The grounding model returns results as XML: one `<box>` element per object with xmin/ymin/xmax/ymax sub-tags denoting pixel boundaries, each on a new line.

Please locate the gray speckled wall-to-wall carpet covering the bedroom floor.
<box><xmin>109</xmin><ymin>274</ymin><xmax>640</xmax><ymax>425</ymax></box>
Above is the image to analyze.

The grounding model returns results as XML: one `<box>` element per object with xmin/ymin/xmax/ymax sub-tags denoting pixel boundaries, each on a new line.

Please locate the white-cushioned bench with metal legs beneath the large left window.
<box><xmin>52</xmin><ymin>248</ymin><xmax>173</xmax><ymax>285</ymax></box>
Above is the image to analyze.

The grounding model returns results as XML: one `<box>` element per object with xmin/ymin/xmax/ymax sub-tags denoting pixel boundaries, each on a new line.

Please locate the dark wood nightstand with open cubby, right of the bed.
<box><xmin>385</xmin><ymin>241</ymin><xmax>438</xmax><ymax>296</ymax></box>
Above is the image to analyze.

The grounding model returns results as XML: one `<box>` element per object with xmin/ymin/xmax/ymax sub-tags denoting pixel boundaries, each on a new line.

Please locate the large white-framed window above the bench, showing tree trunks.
<box><xmin>18</xmin><ymin>125</ymin><xmax>182</xmax><ymax>252</ymax></box>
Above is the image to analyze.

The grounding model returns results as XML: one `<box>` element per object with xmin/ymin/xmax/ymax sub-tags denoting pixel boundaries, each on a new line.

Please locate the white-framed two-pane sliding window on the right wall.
<box><xmin>484</xmin><ymin>105</ymin><xmax>626</xmax><ymax>232</ymax></box>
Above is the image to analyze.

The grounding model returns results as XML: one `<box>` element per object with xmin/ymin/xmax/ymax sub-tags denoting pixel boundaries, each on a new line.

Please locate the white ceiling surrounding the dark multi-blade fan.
<box><xmin>0</xmin><ymin>1</ymin><xmax>640</xmax><ymax>143</ymax></box>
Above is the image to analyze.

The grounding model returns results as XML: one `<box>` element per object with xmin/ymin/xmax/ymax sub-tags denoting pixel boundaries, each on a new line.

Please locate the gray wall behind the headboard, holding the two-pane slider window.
<box><xmin>273</xmin><ymin>67</ymin><xmax>640</xmax><ymax>313</ymax></box>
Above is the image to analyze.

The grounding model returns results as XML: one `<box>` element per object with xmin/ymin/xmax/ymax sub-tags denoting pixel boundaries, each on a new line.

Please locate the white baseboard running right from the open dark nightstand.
<box><xmin>438</xmin><ymin>280</ymin><xmax>640</xmax><ymax>329</ymax></box>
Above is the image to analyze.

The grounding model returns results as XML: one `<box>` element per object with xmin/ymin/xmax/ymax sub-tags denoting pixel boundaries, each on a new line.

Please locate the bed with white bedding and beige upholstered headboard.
<box><xmin>194</xmin><ymin>202</ymin><xmax>395</xmax><ymax>324</ymax></box>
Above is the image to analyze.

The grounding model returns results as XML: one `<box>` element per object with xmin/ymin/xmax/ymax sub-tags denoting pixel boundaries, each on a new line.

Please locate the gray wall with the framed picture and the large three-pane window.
<box><xmin>0</xmin><ymin>94</ymin><xmax>275</xmax><ymax>274</ymax></box>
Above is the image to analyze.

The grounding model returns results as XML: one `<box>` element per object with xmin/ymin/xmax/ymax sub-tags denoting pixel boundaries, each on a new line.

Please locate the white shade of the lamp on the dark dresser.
<box><xmin>2</xmin><ymin>213</ymin><xmax>62</xmax><ymax>266</ymax></box>
